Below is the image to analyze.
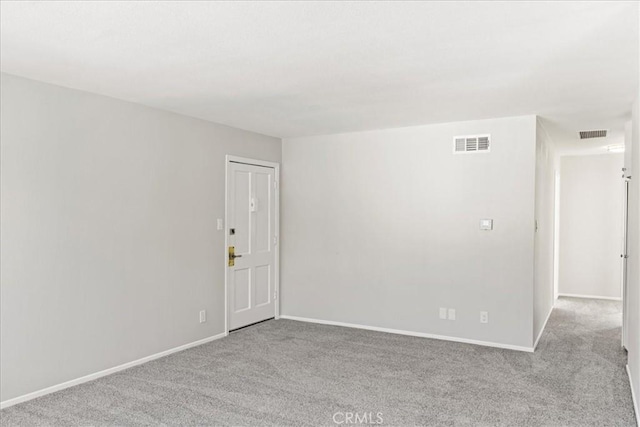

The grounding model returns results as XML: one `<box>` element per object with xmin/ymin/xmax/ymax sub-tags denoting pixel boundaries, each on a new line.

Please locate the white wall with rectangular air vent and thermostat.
<box><xmin>281</xmin><ymin>116</ymin><xmax>536</xmax><ymax>347</ymax></box>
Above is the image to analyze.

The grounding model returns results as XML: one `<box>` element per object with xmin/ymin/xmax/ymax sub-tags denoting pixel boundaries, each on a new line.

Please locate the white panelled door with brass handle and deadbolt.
<box><xmin>227</xmin><ymin>162</ymin><xmax>277</xmax><ymax>330</ymax></box>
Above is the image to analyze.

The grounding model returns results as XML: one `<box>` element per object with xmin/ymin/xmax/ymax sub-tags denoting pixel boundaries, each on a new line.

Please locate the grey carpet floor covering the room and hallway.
<box><xmin>0</xmin><ymin>298</ymin><xmax>636</xmax><ymax>426</ymax></box>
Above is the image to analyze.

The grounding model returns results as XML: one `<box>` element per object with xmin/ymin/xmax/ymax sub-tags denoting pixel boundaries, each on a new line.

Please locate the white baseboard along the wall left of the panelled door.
<box><xmin>0</xmin><ymin>332</ymin><xmax>227</xmax><ymax>409</ymax></box>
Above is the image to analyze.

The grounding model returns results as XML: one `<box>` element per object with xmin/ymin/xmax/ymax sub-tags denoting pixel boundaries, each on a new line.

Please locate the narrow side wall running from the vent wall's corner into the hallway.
<box><xmin>533</xmin><ymin>121</ymin><xmax>558</xmax><ymax>339</ymax></box>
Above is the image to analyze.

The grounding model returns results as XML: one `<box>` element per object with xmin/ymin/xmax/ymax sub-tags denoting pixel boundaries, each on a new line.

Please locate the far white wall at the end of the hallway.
<box><xmin>559</xmin><ymin>154</ymin><xmax>624</xmax><ymax>298</ymax></box>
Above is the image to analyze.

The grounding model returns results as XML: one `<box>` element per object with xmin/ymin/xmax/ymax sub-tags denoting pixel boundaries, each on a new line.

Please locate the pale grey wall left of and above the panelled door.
<box><xmin>0</xmin><ymin>74</ymin><xmax>281</xmax><ymax>401</ymax></box>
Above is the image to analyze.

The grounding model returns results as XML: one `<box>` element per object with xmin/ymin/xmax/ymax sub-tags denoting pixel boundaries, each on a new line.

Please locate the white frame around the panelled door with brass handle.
<box><xmin>223</xmin><ymin>154</ymin><xmax>280</xmax><ymax>336</ymax></box>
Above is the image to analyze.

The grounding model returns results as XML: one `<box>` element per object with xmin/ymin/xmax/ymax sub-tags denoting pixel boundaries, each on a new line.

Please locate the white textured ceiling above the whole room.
<box><xmin>0</xmin><ymin>2</ymin><xmax>638</xmax><ymax>152</ymax></box>
